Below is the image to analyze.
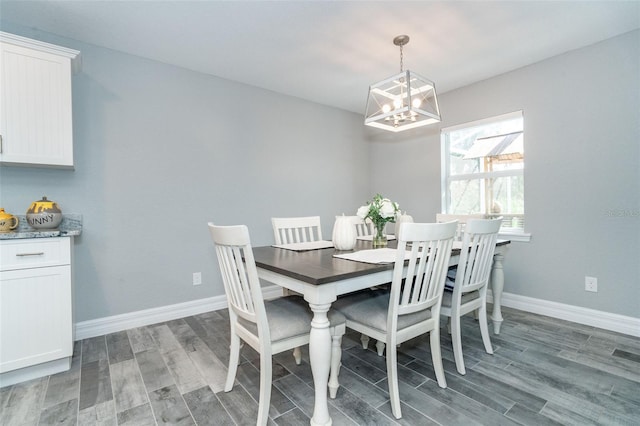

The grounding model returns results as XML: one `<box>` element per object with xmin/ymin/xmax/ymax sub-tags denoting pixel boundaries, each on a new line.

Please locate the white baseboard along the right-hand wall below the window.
<box><xmin>487</xmin><ymin>292</ymin><xmax>640</xmax><ymax>337</ymax></box>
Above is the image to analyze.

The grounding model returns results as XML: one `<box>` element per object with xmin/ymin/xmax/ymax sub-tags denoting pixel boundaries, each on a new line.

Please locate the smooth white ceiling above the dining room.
<box><xmin>0</xmin><ymin>0</ymin><xmax>640</xmax><ymax>113</ymax></box>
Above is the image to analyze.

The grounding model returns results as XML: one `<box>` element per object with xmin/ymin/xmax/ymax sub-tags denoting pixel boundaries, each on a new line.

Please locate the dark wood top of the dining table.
<box><xmin>253</xmin><ymin>240</ymin><xmax>509</xmax><ymax>285</ymax></box>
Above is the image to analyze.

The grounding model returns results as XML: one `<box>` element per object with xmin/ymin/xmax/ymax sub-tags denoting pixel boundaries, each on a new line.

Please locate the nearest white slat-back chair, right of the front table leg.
<box><xmin>333</xmin><ymin>222</ymin><xmax>457</xmax><ymax>419</ymax></box>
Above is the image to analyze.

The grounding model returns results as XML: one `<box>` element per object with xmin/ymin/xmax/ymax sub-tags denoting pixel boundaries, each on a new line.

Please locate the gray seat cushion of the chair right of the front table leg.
<box><xmin>333</xmin><ymin>290</ymin><xmax>431</xmax><ymax>333</ymax></box>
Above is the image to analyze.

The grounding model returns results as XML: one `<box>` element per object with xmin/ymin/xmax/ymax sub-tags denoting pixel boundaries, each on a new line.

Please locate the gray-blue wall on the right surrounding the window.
<box><xmin>369</xmin><ymin>31</ymin><xmax>640</xmax><ymax>318</ymax></box>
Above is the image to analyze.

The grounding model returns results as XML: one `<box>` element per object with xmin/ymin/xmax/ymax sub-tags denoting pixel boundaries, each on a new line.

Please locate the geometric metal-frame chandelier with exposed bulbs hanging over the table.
<box><xmin>364</xmin><ymin>35</ymin><xmax>440</xmax><ymax>132</ymax></box>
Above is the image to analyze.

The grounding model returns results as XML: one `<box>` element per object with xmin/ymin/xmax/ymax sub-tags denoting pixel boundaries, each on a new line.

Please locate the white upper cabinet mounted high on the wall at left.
<box><xmin>0</xmin><ymin>32</ymin><xmax>80</xmax><ymax>168</ymax></box>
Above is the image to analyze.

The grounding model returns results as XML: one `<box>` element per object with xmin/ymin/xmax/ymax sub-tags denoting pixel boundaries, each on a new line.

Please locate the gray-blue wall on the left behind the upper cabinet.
<box><xmin>0</xmin><ymin>25</ymin><xmax>370</xmax><ymax>321</ymax></box>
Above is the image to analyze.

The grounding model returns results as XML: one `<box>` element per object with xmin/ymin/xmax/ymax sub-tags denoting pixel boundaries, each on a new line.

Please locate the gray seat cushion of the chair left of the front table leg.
<box><xmin>238</xmin><ymin>296</ymin><xmax>345</xmax><ymax>342</ymax></box>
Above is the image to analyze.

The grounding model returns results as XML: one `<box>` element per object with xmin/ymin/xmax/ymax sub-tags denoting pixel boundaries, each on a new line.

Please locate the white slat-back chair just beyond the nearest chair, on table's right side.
<box><xmin>440</xmin><ymin>217</ymin><xmax>502</xmax><ymax>374</ymax></box>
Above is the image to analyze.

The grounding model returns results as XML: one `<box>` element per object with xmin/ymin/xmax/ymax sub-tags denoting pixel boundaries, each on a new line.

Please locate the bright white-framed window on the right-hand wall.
<box><xmin>441</xmin><ymin>111</ymin><xmax>525</xmax><ymax>238</ymax></box>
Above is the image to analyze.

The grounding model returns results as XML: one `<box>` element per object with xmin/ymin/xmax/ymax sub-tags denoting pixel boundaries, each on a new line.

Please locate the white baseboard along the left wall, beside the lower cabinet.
<box><xmin>75</xmin><ymin>285</ymin><xmax>282</xmax><ymax>340</ymax></box>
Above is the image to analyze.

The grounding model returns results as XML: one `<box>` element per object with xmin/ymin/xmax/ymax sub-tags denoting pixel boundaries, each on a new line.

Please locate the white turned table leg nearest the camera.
<box><xmin>309</xmin><ymin>303</ymin><xmax>331</xmax><ymax>426</ymax></box>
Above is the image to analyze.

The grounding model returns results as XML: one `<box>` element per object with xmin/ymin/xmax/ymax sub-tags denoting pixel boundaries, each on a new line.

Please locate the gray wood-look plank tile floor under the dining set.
<box><xmin>0</xmin><ymin>309</ymin><xmax>640</xmax><ymax>426</ymax></box>
